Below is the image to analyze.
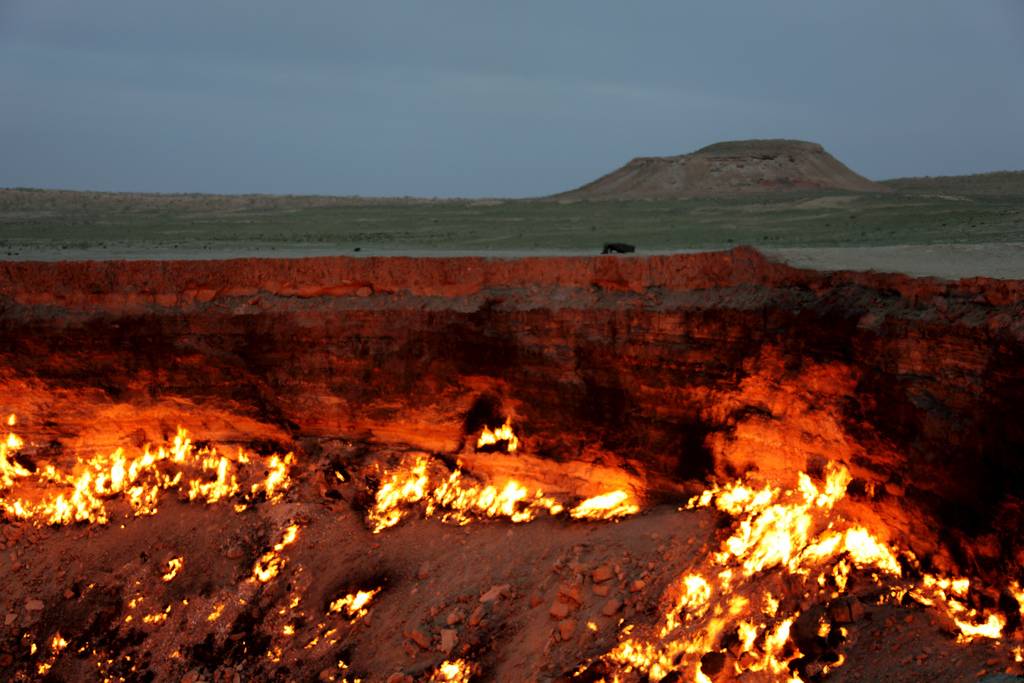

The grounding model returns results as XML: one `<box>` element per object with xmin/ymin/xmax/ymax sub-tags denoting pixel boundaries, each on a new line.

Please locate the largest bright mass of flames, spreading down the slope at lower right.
<box><xmin>604</xmin><ymin>464</ymin><xmax>1005</xmax><ymax>681</ymax></box>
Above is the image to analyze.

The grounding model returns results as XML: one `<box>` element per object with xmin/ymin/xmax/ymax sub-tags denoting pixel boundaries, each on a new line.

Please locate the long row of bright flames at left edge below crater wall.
<box><xmin>0</xmin><ymin>416</ymin><xmax>295</xmax><ymax>524</ymax></box>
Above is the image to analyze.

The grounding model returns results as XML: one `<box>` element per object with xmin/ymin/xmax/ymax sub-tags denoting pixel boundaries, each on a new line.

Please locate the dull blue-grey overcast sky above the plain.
<box><xmin>0</xmin><ymin>0</ymin><xmax>1024</xmax><ymax>197</ymax></box>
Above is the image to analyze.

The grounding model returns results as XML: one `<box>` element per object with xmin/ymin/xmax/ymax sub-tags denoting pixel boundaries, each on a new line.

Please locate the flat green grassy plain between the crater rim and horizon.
<box><xmin>0</xmin><ymin>173</ymin><xmax>1024</xmax><ymax>266</ymax></box>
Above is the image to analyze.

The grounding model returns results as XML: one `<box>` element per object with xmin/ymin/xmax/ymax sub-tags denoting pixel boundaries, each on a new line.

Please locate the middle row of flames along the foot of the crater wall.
<box><xmin>367</xmin><ymin>455</ymin><xmax>639</xmax><ymax>532</ymax></box>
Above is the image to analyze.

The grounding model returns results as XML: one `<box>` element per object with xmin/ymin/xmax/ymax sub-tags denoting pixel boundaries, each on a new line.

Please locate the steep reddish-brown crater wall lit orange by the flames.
<box><xmin>0</xmin><ymin>249</ymin><xmax>1024</xmax><ymax>679</ymax></box>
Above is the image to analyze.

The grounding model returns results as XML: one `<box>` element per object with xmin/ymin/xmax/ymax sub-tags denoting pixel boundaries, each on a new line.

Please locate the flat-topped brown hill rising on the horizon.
<box><xmin>555</xmin><ymin>140</ymin><xmax>889</xmax><ymax>200</ymax></box>
